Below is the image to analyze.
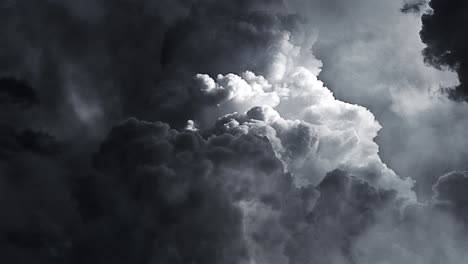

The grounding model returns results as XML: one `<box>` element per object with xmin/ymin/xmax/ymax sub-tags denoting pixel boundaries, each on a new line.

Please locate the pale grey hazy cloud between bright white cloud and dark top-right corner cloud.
<box><xmin>274</xmin><ymin>0</ymin><xmax>468</xmax><ymax>199</ymax></box>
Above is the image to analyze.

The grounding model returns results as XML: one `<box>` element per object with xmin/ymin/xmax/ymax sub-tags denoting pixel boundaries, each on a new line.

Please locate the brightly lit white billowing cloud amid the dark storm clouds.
<box><xmin>195</xmin><ymin>35</ymin><xmax>414</xmax><ymax>198</ymax></box>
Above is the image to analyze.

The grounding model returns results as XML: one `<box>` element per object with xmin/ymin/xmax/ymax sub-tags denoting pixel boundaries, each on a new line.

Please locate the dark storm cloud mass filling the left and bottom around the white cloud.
<box><xmin>0</xmin><ymin>0</ymin><xmax>466</xmax><ymax>264</ymax></box>
